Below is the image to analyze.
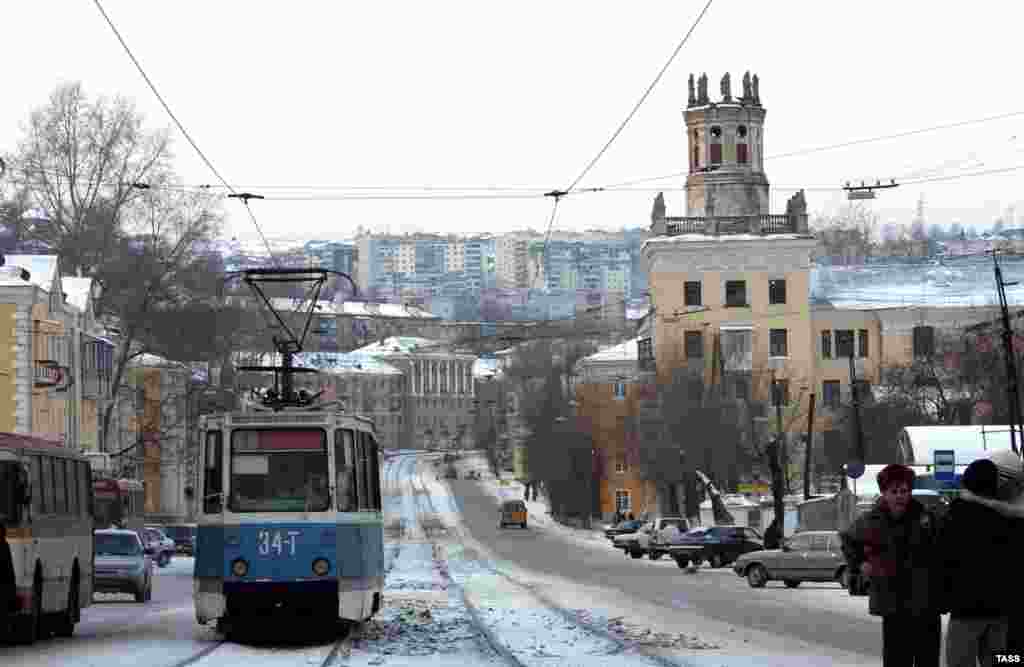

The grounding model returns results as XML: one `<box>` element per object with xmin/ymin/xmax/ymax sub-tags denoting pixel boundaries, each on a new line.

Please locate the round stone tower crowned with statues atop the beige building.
<box><xmin>684</xmin><ymin>72</ymin><xmax>769</xmax><ymax>216</ymax></box>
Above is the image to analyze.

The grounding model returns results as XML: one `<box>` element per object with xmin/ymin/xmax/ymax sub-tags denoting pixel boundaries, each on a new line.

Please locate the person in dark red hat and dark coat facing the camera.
<box><xmin>841</xmin><ymin>464</ymin><xmax>942</xmax><ymax>667</ymax></box>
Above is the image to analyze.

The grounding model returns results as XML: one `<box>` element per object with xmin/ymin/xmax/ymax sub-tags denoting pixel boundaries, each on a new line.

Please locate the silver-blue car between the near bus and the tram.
<box><xmin>93</xmin><ymin>530</ymin><xmax>153</xmax><ymax>602</ymax></box>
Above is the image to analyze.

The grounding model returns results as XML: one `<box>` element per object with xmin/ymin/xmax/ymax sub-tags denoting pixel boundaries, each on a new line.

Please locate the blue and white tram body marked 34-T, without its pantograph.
<box><xmin>194</xmin><ymin>409</ymin><xmax>384</xmax><ymax>627</ymax></box>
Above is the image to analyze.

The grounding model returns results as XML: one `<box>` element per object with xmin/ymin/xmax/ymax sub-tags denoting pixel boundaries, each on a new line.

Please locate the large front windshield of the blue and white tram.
<box><xmin>229</xmin><ymin>428</ymin><xmax>331</xmax><ymax>512</ymax></box>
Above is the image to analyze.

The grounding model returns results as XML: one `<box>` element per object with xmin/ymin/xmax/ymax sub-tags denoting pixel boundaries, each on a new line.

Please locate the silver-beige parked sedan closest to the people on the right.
<box><xmin>732</xmin><ymin>531</ymin><xmax>847</xmax><ymax>588</ymax></box>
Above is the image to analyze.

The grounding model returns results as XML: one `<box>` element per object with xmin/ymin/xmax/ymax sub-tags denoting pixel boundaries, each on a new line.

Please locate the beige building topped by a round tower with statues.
<box><xmin>641</xmin><ymin>71</ymin><xmax>1007</xmax><ymax>479</ymax></box>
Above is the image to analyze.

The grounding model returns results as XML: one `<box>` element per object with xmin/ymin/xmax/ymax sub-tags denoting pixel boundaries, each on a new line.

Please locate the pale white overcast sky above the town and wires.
<box><xmin>0</xmin><ymin>0</ymin><xmax>1024</xmax><ymax>244</ymax></box>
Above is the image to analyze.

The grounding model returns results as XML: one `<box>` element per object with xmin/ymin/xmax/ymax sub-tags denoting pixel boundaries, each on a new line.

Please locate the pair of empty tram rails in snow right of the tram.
<box><xmin>413</xmin><ymin>456</ymin><xmax>687</xmax><ymax>667</ymax></box>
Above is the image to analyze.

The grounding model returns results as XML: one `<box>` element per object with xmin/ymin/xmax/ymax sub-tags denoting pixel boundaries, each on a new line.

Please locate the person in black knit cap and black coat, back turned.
<box><xmin>939</xmin><ymin>459</ymin><xmax>1015</xmax><ymax>667</ymax></box>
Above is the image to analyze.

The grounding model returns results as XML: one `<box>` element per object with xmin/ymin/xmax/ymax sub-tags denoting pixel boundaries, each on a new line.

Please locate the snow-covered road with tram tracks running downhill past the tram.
<box><xmin>0</xmin><ymin>454</ymin><xmax>881</xmax><ymax>667</ymax></box>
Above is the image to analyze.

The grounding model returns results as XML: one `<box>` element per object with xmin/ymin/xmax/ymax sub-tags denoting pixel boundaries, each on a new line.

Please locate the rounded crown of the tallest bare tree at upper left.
<box><xmin>8</xmin><ymin>83</ymin><xmax>173</xmax><ymax>276</ymax></box>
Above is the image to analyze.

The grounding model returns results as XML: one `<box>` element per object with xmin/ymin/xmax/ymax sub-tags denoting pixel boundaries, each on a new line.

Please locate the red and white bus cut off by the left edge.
<box><xmin>0</xmin><ymin>432</ymin><xmax>93</xmax><ymax>643</ymax></box>
